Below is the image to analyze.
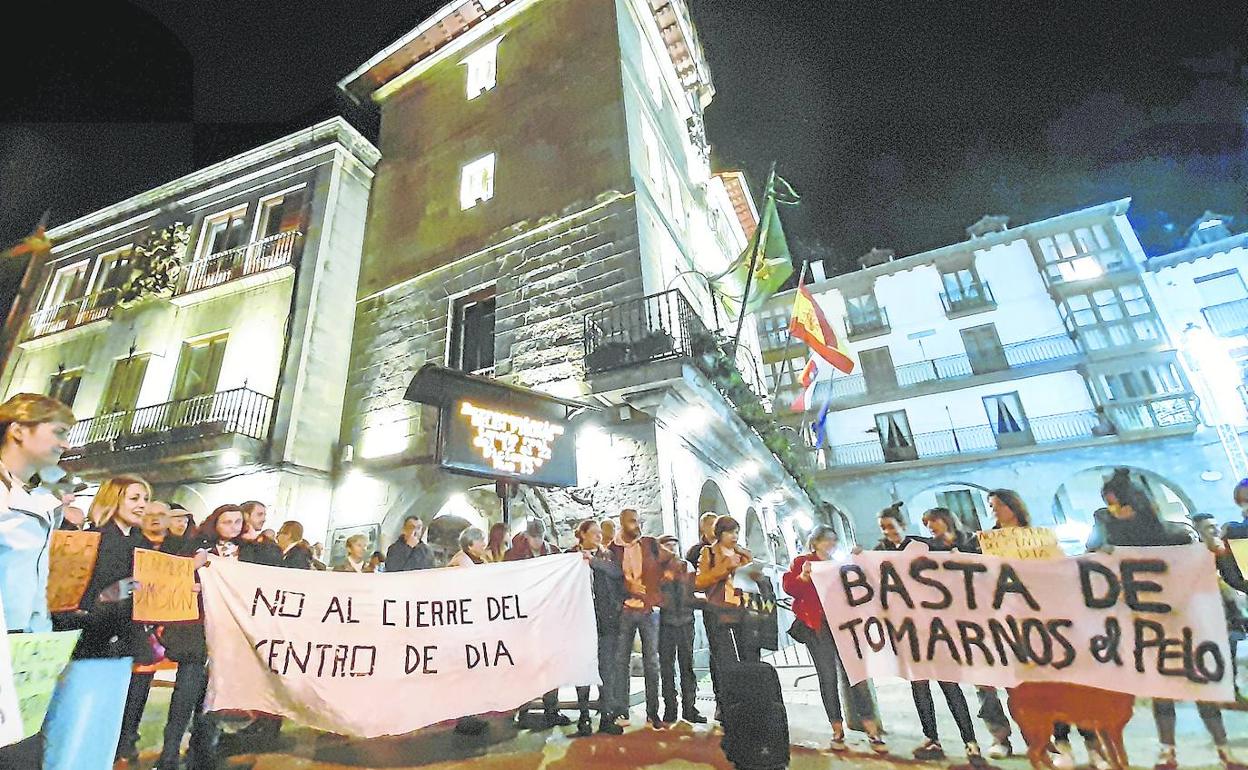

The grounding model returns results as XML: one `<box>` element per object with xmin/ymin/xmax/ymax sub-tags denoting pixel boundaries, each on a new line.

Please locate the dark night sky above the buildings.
<box><xmin>0</xmin><ymin>0</ymin><xmax>1248</xmax><ymax>288</ymax></box>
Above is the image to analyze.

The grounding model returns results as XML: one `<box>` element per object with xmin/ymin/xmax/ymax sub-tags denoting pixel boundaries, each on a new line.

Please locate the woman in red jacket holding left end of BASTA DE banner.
<box><xmin>781</xmin><ymin>524</ymin><xmax>889</xmax><ymax>754</ymax></box>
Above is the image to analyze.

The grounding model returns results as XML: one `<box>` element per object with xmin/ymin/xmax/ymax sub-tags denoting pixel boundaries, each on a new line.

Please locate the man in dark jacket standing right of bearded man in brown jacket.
<box><xmin>659</xmin><ymin>534</ymin><xmax>706</xmax><ymax>724</ymax></box>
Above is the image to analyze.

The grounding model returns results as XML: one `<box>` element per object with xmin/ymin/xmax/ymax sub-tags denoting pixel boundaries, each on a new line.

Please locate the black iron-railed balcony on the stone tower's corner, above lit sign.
<box><xmin>585</xmin><ymin>290</ymin><xmax>709</xmax><ymax>374</ymax></box>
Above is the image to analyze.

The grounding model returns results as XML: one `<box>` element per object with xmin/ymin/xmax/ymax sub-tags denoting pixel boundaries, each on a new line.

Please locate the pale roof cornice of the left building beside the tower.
<box><xmin>47</xmin><ymin>117</ymin><xmax>381</xmax><ymax>244</ymax></box>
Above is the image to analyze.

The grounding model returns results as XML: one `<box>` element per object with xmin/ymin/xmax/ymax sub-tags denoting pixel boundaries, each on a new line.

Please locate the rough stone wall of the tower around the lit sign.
<box><xmin>334</xmin><ymin>193</ymin><xmax>660</xmax><ymax>534</ymax></box>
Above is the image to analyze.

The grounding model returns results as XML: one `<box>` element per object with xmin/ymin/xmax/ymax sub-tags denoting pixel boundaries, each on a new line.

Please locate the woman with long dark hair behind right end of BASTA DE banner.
<box><xmin>1099</xmin><ymin>468</ymin><xmax>1248</xmax><ymax>770</ymax></box>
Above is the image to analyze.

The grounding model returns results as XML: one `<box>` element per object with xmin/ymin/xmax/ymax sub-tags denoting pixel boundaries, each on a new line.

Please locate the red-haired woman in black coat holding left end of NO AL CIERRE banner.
<box><xmin>156</xmin><ymin>505</ymin><xmax>281</xmax><ymax>770</ymax></box>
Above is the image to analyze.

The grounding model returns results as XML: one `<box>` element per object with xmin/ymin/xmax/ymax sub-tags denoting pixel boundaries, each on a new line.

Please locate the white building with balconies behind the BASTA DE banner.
<box><xmin>761</xmin><ymin>200</ymin><xmax>1233</xmax><ymax>548</ymax></box>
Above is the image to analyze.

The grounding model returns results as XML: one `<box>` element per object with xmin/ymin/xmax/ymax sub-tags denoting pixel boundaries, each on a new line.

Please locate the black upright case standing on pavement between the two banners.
<box><xmin>719</xmin><ymin>663</ymin><xmax>789</xmax><ymax>770</ymax></box>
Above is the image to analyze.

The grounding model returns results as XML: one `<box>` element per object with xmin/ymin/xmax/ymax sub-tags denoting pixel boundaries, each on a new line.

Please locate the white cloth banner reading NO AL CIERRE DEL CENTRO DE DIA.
<box><xmin>200</xmin><ymin>554</ymin><xmax>599</xmax><ymax>738</ymax></box>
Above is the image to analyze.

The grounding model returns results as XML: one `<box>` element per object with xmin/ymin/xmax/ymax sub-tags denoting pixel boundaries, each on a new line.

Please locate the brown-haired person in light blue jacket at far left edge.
<box><xmin>0</xmin><ymin>393</ymin><xmax>75</xmax><ymax>768</ymax></box>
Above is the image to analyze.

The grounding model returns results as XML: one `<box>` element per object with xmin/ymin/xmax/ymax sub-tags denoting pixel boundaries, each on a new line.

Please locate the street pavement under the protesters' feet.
<box><xmin>129</xmin><ymin>653</ymin><xmax>1248</xmax><ymax>770</ymax></box>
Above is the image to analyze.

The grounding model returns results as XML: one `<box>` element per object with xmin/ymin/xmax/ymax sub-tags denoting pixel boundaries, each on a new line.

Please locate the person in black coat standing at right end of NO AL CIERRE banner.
<box><xmin>569</xmin><ymin>519</ymin><xmax>628</xmax><ymax>735</ymax></box>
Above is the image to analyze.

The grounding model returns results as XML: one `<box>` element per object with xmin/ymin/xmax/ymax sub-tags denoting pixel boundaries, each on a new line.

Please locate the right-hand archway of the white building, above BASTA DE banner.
<box><xmin>1053</xmin><ymin>465</ymin><xmax>1196</xmax><ymax>553</ymax></box>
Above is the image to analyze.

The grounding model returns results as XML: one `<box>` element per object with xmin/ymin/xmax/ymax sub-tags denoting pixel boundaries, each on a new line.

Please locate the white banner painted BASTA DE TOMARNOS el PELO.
<box><xmin>811</xmin><ymin>543</ymin><xmax>1234</xmax><ymax>701</ymax></box>
